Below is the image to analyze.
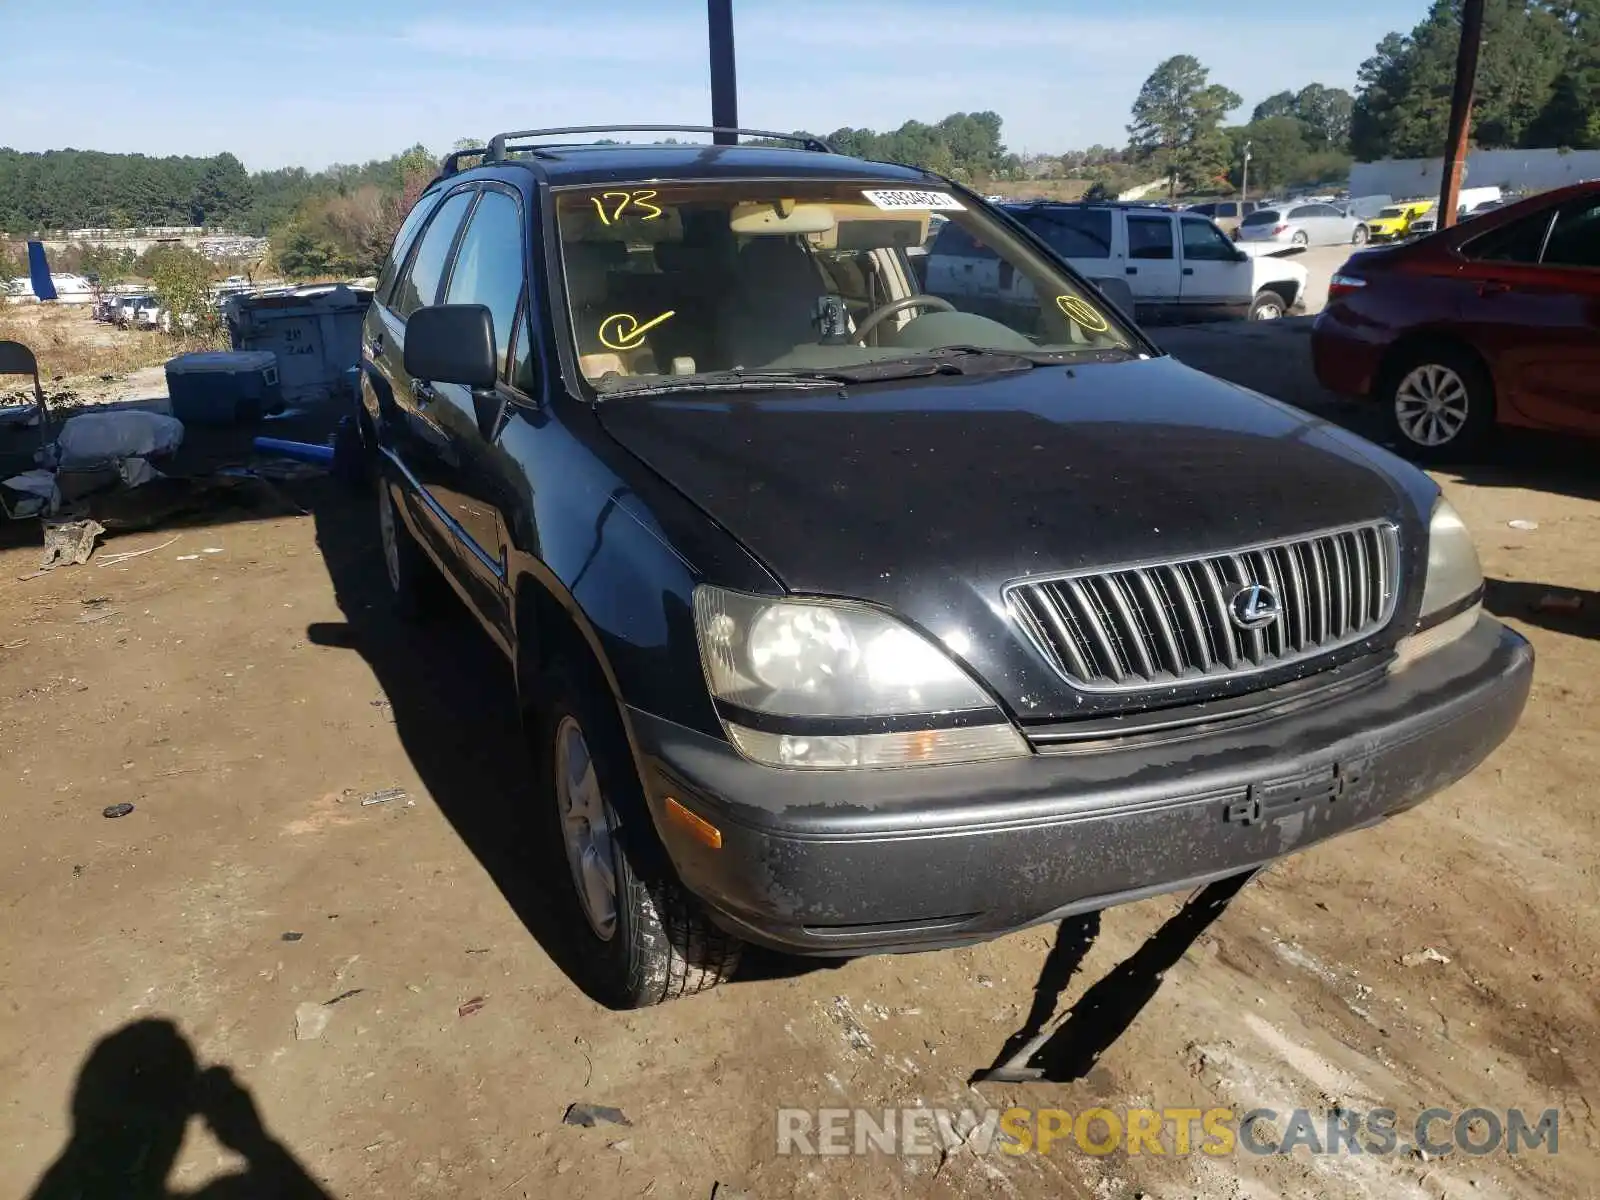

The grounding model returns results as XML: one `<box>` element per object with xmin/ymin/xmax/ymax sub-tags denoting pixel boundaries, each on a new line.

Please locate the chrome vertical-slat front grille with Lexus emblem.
<box><xmin>1005</xmin><ymin>523</ymin><xmax>1400</xmax><ymax>691</ymax></box>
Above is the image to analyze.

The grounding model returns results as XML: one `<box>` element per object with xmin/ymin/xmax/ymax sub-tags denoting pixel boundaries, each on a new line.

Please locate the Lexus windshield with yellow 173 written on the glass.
<box><xmin>555</xmin><ymin>181</ymin><xmax>1136</xmax><ymax>390</ymax></box>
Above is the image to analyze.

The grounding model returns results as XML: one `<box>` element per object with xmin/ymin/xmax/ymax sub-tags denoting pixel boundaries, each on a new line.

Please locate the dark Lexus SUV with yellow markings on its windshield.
<box><xmin>360</xmin><ymin>130</ymin><xmax>1533</xmax><ymax>1006</ymax></box>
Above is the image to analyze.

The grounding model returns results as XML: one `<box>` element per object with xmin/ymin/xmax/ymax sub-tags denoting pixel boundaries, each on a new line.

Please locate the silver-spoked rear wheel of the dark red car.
<box><xmin>1381</xmin><ymin>346</ymin><xmax>1494</xmax><ymax>462</ymax></box>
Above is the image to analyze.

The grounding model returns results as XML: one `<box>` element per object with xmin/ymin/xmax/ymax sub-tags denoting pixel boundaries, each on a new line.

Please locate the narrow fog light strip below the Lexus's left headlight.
<box><xmin>728</xmin><ymin>722</ymin><xmax>1029</xmax><ymax>771</ymax></box>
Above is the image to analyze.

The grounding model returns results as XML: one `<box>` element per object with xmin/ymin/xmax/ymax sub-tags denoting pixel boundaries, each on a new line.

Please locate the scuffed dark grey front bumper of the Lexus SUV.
<box><xmin>630</xmin><ymin>618</ymin><xmax>1533</xmax><ymax>955</ymax></box>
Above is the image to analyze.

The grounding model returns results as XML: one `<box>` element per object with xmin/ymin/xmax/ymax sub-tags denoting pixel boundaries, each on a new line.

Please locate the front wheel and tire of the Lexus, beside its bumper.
<box><xmin>530</xmin><ymin>666</ymin><xmax>744</xmax><ymax>1008</ymax></box>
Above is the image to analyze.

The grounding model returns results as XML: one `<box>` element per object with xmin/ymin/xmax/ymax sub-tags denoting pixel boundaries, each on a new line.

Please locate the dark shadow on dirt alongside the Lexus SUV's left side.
<box><xmin>298</xmin><ymin>480</ymin><xmax>837</xmax><ymax>998</ymax></box>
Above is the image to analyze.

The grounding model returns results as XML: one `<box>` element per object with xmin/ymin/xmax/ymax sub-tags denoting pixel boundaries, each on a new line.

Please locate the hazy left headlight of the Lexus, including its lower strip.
<box><xmin>694</xmin><ymin>586</ymin><xmax>1027</xmax><ymax>768</ymax></box>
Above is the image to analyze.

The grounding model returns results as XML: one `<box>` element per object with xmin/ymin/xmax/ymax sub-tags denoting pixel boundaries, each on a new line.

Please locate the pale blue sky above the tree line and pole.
<box><xmin>0</xmin><ymin>0</ymin><xmax>1426</xmax><ymax>168</ymax></box>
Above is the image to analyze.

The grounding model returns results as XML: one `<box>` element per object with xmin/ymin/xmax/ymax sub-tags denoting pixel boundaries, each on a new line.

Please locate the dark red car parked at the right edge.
<box><xmin>1312</xmin><ymin>181</ymin><xmax>1600</xmax><ymax>461</ymax></box>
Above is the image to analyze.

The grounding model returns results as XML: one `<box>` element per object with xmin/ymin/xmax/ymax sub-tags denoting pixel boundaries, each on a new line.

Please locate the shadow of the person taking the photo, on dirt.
<box><xmin>29</xmin><ymin>1019</ymin><xmax>331</xmax><ymax>1200</ymax></box>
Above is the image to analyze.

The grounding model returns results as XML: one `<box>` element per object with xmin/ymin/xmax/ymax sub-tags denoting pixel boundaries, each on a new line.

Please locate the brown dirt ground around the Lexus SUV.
<box><xmin>0</xmin><ymin>329</ymin><xmax>1600</xmax><ymax>1200</ymax></box>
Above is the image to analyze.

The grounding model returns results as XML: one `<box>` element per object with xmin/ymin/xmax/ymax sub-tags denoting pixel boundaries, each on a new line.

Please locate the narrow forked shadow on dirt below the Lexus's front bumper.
<box><xmin>970</xmin><ymin>870</ymin><xmax>1256</xmax><ymax>1083</ymax></box>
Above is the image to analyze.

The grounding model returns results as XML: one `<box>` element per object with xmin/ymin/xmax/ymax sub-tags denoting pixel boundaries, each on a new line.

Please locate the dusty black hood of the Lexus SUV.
<box><xmin>598</xmin><ymin>358</ymin><xmax>1430</xmax><ymax>720</ymax></box>
